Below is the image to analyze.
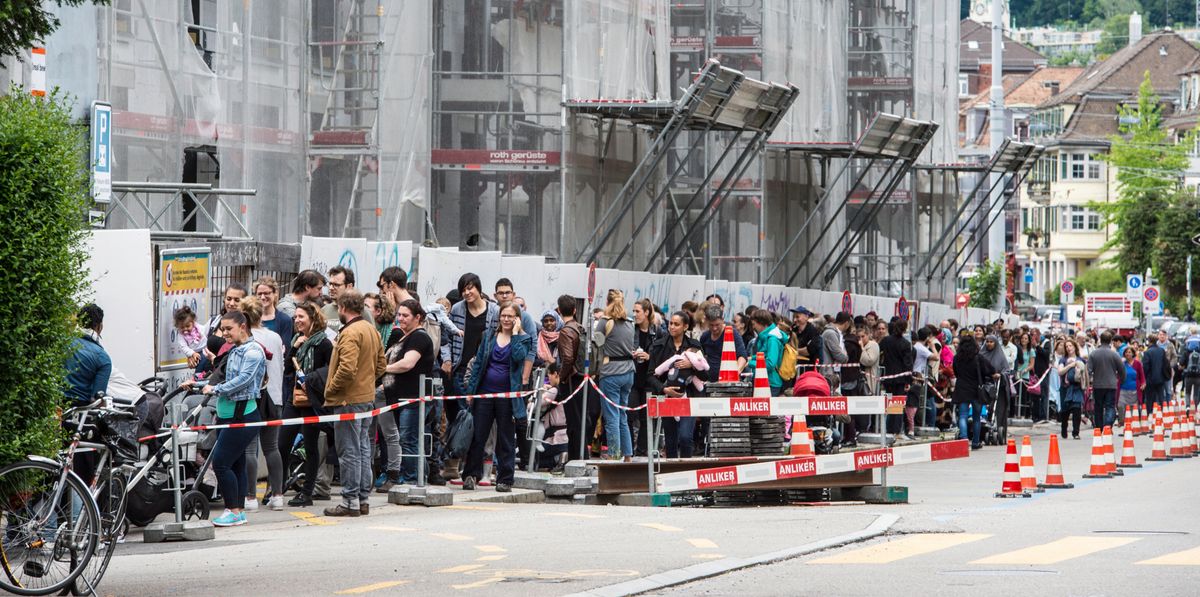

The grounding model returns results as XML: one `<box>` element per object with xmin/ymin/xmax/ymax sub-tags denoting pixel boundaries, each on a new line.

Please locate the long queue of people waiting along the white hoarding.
<box><xmin>60</xmin><ymin>266</ymin><xmax>1200</xmax><ymax>526</ymax></box>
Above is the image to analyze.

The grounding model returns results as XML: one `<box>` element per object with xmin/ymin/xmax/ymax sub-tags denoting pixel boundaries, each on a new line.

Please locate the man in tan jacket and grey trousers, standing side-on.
<box><xmin>325</xmin><ymin>289</ymin><xmax>391</xmax><ymax>517</ymax></box>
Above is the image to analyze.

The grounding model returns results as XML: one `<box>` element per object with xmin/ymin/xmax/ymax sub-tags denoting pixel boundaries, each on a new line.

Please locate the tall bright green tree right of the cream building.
<box><xmin>1092</xmin><ymin>71</ymin><xmax>1190</xmax><ymax>272</ymax></box>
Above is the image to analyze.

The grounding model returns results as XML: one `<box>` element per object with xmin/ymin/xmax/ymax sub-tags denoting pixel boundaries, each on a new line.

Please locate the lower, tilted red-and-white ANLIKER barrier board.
<box><xmin>654</xmin><ymin>440</ymin><xmax>971</xmax><ymax>493</ymax></box>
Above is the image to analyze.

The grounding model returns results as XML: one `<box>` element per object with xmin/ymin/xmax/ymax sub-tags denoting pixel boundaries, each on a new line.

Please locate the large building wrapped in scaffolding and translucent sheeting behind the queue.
<box><xmin>7</xmin><ymin>0</ymin><xmax>960</xmax><ymax>297</ymax></box>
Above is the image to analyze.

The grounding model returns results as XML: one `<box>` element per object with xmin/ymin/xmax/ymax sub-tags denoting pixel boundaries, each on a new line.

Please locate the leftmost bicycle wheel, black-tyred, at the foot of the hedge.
<box><xmin>0</xmin><ymin>460</ymin><xmax>101</xmax><ymax>595</ymax></box>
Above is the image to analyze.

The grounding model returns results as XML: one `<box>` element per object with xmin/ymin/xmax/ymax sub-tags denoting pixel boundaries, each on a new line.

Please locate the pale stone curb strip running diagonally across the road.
<box><xmin>568</xmin><ymin>514</ymin><xmax>900</xmax><ymax>597</ymax></box>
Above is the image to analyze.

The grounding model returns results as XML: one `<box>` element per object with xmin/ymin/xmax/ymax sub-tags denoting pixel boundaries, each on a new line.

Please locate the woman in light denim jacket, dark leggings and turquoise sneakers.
<box><xmin>185</xmin><ymin>310</ymin><xmax>266</xmax><ymax>526</ymax></box>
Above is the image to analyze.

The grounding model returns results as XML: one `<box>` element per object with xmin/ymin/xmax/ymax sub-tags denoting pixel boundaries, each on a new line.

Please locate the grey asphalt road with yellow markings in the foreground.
<box><xmin>102</xmin><ymin>421</ymin><xmax>1200</xmax><ymax>597</ymax></box>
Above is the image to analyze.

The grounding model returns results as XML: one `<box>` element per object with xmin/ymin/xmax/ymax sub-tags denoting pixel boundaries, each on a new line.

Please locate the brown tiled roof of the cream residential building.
<box><xmin>1039</xmin><ymin>30</ymin><xmax>1200</xmax><ymax>108</ymax></box>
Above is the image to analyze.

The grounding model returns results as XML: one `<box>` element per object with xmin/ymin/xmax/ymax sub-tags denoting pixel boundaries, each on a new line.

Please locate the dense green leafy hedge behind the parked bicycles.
<box><xmin>0</xmin><ymin>88</ymin><xmax>88</xmax><ymax>465</ymax></box>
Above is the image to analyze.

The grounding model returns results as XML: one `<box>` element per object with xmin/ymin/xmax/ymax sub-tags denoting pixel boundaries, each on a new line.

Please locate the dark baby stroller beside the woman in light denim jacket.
<box><xmin>125</xmin><ymin>387</ymin><xmax>215</xmax><ymax>526</ymax></box>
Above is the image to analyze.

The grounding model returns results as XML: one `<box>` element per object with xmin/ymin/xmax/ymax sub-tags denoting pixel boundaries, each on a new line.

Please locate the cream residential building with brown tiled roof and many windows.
<box><xmin>1018</xmin><ymin>30</ymin><xmax>1200</xmax><ymax>296</ymax></box>
